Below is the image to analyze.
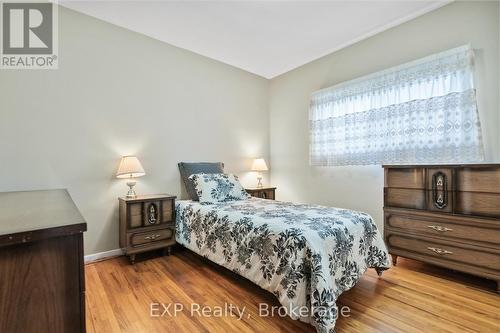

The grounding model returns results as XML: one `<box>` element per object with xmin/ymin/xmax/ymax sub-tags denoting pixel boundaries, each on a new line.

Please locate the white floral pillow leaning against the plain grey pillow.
<box><xmin>189</xmin><ymin>173</ymin><xmax>250</xmax><ymax>203</ymax></box>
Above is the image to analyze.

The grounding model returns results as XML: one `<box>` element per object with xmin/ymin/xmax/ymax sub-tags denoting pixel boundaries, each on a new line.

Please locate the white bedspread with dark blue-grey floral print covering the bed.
<box><xmin>176</xmin><ymin>198</ymin><xmax>391</xmax><ymax>333</ymax></box>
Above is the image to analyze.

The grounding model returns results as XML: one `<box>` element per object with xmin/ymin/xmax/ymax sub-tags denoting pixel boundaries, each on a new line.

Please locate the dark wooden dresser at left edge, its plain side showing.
<box><xmin>0</xmin><ymin>190</ymin><xmax>87</xmax><ymax>333</ymax></box>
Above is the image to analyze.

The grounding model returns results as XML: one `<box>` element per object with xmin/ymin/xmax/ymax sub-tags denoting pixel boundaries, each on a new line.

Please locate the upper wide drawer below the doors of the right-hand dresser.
<box><xmin>385</xmin><ymin>211</ymin><xmax>500</xmax><ymax>249</ymax></box>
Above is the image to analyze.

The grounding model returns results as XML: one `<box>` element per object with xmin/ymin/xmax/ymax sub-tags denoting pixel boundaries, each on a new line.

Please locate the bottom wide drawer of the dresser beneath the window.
<box><xmin>386</xmin><ymin>232</ymin><xmax>500</xmax><ymax>276</ymax></box>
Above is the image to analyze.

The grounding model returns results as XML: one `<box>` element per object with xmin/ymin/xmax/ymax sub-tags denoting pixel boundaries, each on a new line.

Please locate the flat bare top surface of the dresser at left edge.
<box><xmin>0</xmin><ymin>189</ymin><xmax>86</xmax><ymax>236</ymax></box>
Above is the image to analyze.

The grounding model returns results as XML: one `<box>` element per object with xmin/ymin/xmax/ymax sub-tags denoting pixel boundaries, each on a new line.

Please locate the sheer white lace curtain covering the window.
<box><xmin>309</xmin><ymin>45</ymin><xmax>484</xmax><ymax>166</ymax></box>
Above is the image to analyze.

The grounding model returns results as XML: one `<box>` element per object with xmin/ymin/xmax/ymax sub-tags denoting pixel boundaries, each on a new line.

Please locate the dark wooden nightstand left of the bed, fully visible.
<box><xmin>119</xmin><ymin>194</ymin><xmax>175</xmax><ymax>264</ymax></box>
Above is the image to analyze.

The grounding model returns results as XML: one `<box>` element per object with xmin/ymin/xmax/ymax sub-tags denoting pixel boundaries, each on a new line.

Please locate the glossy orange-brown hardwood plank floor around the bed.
<box><xmin>85</xmin><ymin>249</ymin><xmax>500</xmax><ymax>333</ymax></box>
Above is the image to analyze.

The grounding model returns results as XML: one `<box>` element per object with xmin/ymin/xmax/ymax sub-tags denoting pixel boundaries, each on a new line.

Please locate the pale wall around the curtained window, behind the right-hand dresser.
<box><xmin>269</xmin><ymin>2</ymin><xmax>500</xmax><ymax>227</ymax></box>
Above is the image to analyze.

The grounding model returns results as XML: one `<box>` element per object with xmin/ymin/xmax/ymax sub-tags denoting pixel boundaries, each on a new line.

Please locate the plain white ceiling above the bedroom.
<box><xmin>59</xmin><ymin>0</ymin><xmax>450</xmax><ymax>78</ymax></box>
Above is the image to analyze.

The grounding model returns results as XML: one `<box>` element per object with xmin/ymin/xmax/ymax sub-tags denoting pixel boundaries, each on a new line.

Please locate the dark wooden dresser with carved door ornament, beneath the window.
<box><xmin>384</xmin><ymin>164</ymin><xmax>500</xmax><ymax>291</ymax></box>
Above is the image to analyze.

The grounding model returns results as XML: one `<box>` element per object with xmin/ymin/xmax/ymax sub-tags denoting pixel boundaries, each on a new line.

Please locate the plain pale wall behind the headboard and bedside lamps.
<box><xmin>0</xmin><ymin>7</ymin><xmax>269</xmax><ymax>254</ymax></box>
